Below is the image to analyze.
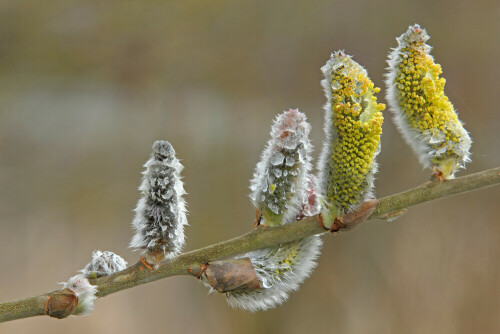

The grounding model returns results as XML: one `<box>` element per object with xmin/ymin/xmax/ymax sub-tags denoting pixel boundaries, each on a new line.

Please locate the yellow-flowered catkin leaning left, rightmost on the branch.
<box><xmin>386</xmin><ymin>24</ymin><xmax>471</xmax><ymax>179</ymax></box>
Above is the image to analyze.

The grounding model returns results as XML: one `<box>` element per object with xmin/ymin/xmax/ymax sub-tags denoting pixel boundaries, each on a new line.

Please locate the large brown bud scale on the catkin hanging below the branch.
<box><xmin>205</xmin><ymin>257</ymin><xmax>260</xmax><ymax>293</ymax></box>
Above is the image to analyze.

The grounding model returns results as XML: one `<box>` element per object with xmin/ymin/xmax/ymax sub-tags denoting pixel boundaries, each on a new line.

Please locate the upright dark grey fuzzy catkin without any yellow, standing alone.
<box><xmin>130</xmin><ymin>141</ymin><xmax>187</xmax><ymax>264</ymax></box>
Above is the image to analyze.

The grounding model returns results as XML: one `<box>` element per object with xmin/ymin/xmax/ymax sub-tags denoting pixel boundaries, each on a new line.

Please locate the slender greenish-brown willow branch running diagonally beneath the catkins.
<box><xmin>0</xmin><ymin>167</ymin><xmax>500</xmax><ymax>322</ymax></box>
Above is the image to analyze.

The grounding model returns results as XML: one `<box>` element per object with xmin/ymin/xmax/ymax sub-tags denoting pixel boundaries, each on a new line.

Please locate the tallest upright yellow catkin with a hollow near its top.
<box><xmin>318</xmin><ymin>51</ymin><xmax>385</xmax><ymax>227</ymax></box>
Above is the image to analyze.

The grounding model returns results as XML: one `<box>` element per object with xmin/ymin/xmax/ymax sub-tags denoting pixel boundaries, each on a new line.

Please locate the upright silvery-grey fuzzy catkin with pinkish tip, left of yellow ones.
<box><xmin>250</xmin><ymin>109</ymin><xmax>312</xmax><ymax>226</ymax></box>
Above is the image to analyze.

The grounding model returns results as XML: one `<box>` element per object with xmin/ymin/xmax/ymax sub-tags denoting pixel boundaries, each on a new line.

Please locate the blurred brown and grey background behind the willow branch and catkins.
<box><xmin>0</xmin><ymin>0</ymin><xmax>500</xmax><ymax>334</ymax></box>
